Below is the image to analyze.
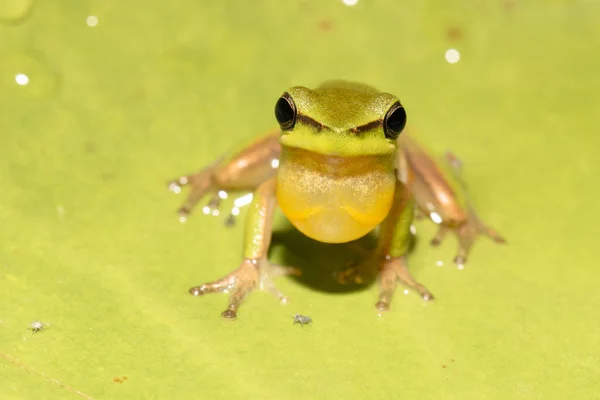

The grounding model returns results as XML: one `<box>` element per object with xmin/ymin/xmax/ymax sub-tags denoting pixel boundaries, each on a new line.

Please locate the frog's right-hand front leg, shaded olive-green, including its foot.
<box><xmin>375</xmin><ymin>182</ymin><xmax>434</xmax><ymax>311</ymax></box>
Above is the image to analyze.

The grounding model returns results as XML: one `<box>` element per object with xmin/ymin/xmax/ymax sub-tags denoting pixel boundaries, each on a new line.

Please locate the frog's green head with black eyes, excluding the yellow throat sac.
<box><xmin>275</xmin><ymin>81</ymin><xmax>406</xmax><ymax>157</ymax></box>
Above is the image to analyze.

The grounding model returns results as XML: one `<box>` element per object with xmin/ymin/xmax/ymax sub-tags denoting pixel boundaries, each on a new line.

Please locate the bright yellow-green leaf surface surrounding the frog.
<box><xmin>0</xmin><ymin>0</ymin><xmax>600</xmax><ymax>400</ymax></box>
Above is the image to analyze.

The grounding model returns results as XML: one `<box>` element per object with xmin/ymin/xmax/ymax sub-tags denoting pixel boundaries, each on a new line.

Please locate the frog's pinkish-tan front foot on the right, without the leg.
<box><xmin>375</xmin><ymin>257</ymin><xmax>434</xmax><ymax>311</ymax></box>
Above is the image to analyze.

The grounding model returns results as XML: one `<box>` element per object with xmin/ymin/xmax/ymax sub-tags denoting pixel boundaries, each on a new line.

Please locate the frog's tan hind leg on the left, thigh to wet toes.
<box><xmin>168</xmin><ymin>130</ymin><xmax>281</xmax><ymax>220</ymax></box>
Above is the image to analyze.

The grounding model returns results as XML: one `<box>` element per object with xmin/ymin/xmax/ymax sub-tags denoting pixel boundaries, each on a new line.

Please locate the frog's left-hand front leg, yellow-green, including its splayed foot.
<box><xmin>189</xmin><ymin>178</ymin><xmax>299</xmax><ymax>319</ymax></box>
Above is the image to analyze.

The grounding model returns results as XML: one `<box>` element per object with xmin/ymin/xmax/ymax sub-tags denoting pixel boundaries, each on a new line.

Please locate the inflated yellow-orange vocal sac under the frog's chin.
<box><xmin>277</xmin><ymin>148</ymin><xmax>396</xmax><ymax>243</ymax></box>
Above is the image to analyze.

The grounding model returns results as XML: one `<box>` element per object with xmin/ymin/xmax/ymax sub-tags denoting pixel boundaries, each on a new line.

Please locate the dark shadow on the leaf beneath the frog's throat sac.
<box><xmin>269</xmin><ymin>221</ymin><xmax>415</xmax><ymax>294</ymax></box>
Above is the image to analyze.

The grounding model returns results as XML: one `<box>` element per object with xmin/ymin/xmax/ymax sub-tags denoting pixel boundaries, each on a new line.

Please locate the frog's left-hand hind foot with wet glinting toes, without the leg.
<box><xmin>168</xmin><ymin>167</ymin><xmax>219</xmax><ymax>222</ymax></box>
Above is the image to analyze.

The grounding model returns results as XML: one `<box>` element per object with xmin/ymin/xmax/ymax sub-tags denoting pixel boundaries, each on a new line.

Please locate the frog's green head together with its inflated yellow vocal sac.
<box><xmin>275</xmin><ymin>81</ymin><xmax>406</xmax><ymax>243</ymax></box>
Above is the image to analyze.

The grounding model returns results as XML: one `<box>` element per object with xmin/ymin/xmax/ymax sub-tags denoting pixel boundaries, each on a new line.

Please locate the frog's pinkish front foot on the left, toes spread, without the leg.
<box><xmin>189</xmin><ymin>259</ymin><xmax>300</xmax><ymax>320</ymax></box>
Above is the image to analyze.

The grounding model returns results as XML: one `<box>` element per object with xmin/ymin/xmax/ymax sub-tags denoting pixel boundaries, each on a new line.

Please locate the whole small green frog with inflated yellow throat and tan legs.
<box><xmin>168</xmin><ymin>80</ymin><xmax>504</xmax><ymax>320</ymax></box>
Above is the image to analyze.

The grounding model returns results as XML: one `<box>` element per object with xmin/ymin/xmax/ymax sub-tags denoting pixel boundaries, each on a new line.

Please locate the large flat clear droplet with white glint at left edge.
<box><xmin>0</xmin><ymin>52</ymin><xmax>59</xmax><ymax>99</ymax></box>
